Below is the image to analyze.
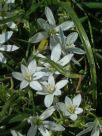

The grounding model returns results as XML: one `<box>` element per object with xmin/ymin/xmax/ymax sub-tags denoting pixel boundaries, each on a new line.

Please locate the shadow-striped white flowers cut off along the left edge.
<box><xmin>0</xmin><ymin>0</ymin><xmax>19</xmax><ymax>63</ymax></box>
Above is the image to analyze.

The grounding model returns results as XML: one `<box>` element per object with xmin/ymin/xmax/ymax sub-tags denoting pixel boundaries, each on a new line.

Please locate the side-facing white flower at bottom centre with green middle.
<box><xmin>27</xmin><ymin>106</ymin><xmax>65</xmax><ymax>136</ymax></box>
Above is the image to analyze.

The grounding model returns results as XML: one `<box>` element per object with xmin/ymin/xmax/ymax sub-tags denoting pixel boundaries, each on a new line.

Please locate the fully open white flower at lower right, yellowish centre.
<box><xmin>58</xmin><ymin>94</ymin><xmax>83</xmax><ymax>121</ymax></box>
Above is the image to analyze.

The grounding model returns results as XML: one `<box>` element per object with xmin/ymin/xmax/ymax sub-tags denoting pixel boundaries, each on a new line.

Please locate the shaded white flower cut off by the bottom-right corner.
<box><xmin>76</xmin><ymin>119</ymin><xmax>102</xmax><ymax>136</ymax></box>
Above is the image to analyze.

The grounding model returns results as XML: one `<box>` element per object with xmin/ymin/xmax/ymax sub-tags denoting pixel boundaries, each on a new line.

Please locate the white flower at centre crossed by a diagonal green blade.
<box><xmin>40</xmin><ymin>44</ymin><xmax>73</xmax><ymax>75</ymax></box>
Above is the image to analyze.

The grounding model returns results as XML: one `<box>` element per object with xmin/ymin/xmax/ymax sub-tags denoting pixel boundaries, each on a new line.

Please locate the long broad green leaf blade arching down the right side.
<box><xmin>63</xmin><ymin>6</ymin><xmax>97</xmax><ymax>104</ymax></box>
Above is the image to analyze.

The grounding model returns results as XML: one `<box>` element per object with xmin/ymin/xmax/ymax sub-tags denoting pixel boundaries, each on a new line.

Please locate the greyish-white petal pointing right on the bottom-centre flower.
<box><xmin>44</xmin><ymin>121</ymin><xmax>65</xmax><ymax>131</ymax></box>
